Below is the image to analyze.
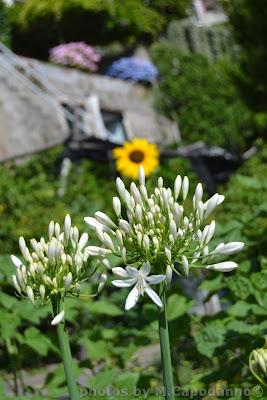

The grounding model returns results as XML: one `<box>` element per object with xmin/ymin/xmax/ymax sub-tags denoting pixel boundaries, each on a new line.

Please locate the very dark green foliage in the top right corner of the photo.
<box><xmin>223</xmin><ymin>0</ymin><xmax>267</xmax><ymax>112</ymax></box>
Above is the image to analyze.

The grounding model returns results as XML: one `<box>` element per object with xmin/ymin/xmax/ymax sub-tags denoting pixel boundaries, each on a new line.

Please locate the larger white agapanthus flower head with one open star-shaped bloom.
<box><xmin>85</xmin><ymin>167</ymin><xmax>244</xmax><ymax>309</ymax></box>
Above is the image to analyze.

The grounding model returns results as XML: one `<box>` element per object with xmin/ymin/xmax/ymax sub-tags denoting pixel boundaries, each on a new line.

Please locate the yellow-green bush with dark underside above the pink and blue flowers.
<box><xmin>9</xmin><ymin>0</ymin><xmax>164</xmax><ymax>58</ymax></box>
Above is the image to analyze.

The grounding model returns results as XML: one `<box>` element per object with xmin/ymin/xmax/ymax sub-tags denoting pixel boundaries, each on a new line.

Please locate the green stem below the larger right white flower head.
<box><xmin>158</xmin><ymin>286</ymin><xmax>174</xmax><ymax>400</ymax></box>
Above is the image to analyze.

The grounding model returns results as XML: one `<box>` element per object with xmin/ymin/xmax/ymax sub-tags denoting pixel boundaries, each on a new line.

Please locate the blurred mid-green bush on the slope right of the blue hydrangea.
<box><xmin>152</xmin><ymin>41</ymin><xmax>256</xmax><ymax>150</ymax></box>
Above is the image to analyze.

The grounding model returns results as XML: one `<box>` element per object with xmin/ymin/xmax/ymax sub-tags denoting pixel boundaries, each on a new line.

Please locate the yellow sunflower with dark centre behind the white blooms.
<box><xmin>113</xmin><ymin>139</ymin><xmax>159</xmax><ymax>179</ymax></box>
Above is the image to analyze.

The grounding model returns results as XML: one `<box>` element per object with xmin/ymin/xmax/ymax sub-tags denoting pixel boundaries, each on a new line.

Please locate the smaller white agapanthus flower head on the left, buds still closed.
<box><xmin>11</xmin><ymin>215</ymin><xmax>89</xmax><ymax>310</ymax></box>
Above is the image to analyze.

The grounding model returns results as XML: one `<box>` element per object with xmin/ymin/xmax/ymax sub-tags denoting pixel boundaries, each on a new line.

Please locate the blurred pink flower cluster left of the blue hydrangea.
<box><xmin>49</xmin><ymin>42</ymin><xmax>101</xmax><ymax>71</ymax></box>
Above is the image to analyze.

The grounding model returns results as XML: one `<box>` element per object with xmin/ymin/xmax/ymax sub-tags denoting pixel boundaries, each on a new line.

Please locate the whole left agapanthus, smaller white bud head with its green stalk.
<box><xmin>11</xmin><ymin>215</ymin><xmax>103</xmax><ymax>400</ymax></box>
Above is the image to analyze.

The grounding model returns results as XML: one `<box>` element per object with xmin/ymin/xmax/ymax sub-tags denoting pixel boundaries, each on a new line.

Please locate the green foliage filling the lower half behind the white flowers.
<box><xmin>0</xmin><ymin>146</ymin><xmax>267</xmax><ymax>400</ymax></box>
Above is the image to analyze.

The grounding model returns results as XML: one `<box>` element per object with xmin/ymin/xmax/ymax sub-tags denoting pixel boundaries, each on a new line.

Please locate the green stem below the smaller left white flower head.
<box><xmin>52</xmin><ymin>298</ymin><xmax>80</xmax><ymax>400</ymax></box>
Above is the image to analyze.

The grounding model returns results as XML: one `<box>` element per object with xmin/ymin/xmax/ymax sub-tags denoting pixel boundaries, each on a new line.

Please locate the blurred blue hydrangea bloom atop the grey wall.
<box><xmin>106</xmin><ymin>57</ymin><xmax>158</xmax><ymax>83</ymax></box>
